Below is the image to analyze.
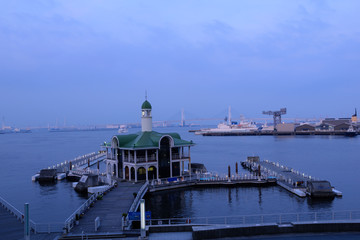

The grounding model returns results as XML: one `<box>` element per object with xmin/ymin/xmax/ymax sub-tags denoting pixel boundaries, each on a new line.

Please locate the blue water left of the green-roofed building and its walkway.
<box><xmin>0</xmin><ymin>131</ymin><xmax>116</xmax><ymax>223</ymax></box>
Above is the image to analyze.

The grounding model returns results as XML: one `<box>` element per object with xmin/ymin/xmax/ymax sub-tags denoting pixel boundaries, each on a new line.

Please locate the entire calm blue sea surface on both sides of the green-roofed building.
<box><xmin>0</xmin><ymin>128</ymin><xmax>360</xmax><ymax>222</ymax></box>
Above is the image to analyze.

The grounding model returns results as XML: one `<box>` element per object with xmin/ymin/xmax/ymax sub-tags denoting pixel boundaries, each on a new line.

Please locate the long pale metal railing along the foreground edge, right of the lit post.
<box><xmin>147</xmin><ymin>211</ymin><xmax>360</xmax><ymax>225</ymax></box>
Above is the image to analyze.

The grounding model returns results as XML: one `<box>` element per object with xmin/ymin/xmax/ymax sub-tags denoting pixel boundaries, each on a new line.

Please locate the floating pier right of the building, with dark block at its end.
<box><xmin>241</xmin><ymin>157</ymin><xmax>342</xmax><ymax>197</ymax></box>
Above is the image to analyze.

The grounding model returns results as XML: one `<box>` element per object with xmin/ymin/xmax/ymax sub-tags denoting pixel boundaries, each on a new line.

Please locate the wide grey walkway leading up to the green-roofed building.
<box><xmin>71</xmin><ymin>182</ymin><xmax>143</xmax><ymax>234</ymax></box>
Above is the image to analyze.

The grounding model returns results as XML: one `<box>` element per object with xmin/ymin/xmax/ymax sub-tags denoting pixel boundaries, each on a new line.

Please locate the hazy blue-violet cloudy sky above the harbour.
<box><xmin>0</xmin><ymin>0</ymin><xmax>360</xmax><ymax>127</ymax></box>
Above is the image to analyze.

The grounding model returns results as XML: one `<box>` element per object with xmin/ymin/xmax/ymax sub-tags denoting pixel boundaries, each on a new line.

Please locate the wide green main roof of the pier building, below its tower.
<box><xmin>113</xmin><ymin>131</ymin><xmax>194</xmax><ymax>149</ymax></box>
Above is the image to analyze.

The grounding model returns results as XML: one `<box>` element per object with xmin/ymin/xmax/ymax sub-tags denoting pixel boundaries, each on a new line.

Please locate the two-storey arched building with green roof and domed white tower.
<box><xmin>104</xmin><ymin>100</ymin><xmax>194</xmax><ymax>182</ymax></box>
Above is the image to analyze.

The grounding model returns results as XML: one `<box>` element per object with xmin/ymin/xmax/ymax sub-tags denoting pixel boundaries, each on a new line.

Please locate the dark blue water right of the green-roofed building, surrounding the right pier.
<box><xmin>147</xmin><ymin>128</ymin><xmax>360</xmax><ymax>218</ymax></box>
